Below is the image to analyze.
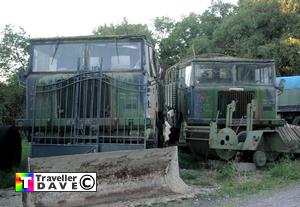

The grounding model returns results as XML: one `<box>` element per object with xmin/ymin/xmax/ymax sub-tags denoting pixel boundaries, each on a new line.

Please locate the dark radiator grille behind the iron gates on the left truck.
<box><xmin>56</xmin><ymin>76</ymin><xmax>112</xmax><ymax>118</ymax></box>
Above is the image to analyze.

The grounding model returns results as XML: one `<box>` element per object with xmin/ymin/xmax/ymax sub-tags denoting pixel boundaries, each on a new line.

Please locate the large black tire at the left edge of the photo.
<box><xmin>0</xmin><ymin>126</ymin><xmax>22</xmax><ymax>170</ymax></box>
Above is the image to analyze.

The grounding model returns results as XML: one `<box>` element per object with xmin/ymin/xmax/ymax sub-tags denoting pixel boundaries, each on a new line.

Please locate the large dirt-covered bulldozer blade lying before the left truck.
<box><xmin>22</xmin><ymin>147</ymin><xmax>194</xmax><ymax>207</ymax></box>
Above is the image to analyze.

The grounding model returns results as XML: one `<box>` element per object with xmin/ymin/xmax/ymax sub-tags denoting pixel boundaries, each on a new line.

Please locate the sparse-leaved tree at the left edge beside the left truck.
<box><xmin>0</xmin><ymin>25</ymin><xmax>29</xmax><ymax>125</ymax></box>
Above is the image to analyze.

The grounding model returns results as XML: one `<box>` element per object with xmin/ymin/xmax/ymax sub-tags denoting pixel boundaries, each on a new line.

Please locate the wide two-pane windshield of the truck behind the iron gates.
<box><xmin>32</xmin><ymin>41</ymin><xmax>142</xmax><ymax>72</ymax></box>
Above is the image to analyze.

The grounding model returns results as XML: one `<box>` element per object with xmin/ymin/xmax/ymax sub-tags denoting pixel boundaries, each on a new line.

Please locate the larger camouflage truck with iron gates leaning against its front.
<box><xmin>0</xmin><ymin>36</ymin><xmax>164</xmax><ymax>166</ymax></box>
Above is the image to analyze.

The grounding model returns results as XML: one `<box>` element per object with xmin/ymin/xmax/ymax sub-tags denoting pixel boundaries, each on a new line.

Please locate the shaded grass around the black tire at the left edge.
<box><xmin>0</xmin><ymin>139</ymin><xmax>31</xmax><ymax>188</ymax></box>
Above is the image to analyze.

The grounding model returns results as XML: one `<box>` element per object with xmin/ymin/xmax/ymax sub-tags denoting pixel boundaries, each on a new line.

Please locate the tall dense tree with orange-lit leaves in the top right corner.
<box><xmin>213</xmin><ymin>0</ymin><xmax>300</xmax><ymax>75</ymax></box>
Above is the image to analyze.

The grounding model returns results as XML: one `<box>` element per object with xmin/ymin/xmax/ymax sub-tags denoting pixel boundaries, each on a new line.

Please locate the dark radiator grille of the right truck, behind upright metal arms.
<box><xmin>218</xmin><ymin>91</ymin><xmax>254</xmax><ymax>119</ymax></box>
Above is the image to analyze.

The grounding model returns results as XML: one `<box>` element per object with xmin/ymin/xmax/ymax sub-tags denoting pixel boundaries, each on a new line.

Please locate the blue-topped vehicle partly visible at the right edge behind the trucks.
<box><xmin>276</xmin><ymin>76</ymin><xmax>300</xmax><ymax>125</ymax></box>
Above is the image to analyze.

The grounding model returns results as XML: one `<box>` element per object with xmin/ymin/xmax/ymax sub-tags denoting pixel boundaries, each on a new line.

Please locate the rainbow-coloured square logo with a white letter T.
<box><xmin>16</xmin><ymin>173</ymin><xmax>34</xmax><ymax>192</ymax></box>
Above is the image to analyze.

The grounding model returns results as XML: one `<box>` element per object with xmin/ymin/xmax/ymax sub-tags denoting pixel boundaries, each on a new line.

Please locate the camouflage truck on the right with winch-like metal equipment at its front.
<box><xmin>164</xmin><ymin>56</ymin><xmax>299</xmax><ymax>166</ymax></box>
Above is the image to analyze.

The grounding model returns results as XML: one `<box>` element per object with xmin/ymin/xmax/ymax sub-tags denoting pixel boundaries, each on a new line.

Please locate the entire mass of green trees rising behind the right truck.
<box><xmin>154</xmin><ymin>0</ymin><xmax>300</xmax><ymax>75</ymax></box>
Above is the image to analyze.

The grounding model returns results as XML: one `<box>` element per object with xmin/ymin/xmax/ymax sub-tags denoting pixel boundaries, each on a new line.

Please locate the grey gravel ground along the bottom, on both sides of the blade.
<box><xmin>0</xmin><ymin>184</ymin><xmax>300</xmax><ymax>207</ymax></box>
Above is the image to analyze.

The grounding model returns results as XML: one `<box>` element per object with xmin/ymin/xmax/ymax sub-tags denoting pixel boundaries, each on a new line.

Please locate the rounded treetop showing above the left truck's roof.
<box><xmin>93</xmin><ymin>18</ymin><xmax>155</xmax><ymax>44</ymax></box>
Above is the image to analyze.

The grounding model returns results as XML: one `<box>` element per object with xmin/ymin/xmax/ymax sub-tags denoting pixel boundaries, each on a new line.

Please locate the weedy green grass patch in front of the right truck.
<box><xmin>179</xmin><ymin>154</ymin><xmax>300</xmax><ymax>196</ymax></box>
